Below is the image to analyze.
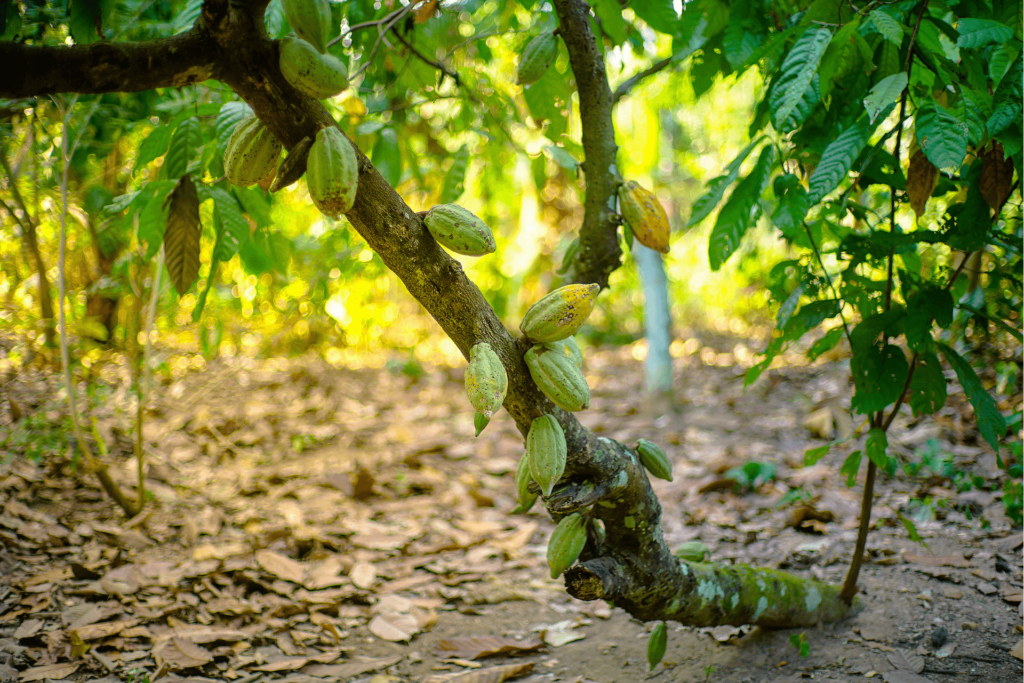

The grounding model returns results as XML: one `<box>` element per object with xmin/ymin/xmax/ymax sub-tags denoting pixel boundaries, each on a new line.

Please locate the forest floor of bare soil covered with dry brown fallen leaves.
<box><xmin>0</xmin><ymin>338</ymin><xmax>1024</xmax><ymax>683</ymax></box>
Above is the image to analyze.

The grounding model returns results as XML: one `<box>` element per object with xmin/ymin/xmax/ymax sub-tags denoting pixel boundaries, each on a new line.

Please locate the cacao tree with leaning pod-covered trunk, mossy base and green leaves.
<box><xmin>0</xmin><ymin>0</ymin><xmax>1021</xmax><ymax>651</ymax></box>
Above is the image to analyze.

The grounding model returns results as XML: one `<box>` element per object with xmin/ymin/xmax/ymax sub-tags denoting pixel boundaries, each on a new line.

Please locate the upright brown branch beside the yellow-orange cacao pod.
<box><xmin>554</xmin><ymin>0</ymin><xmax>623</xmax><ymax>288</ymax></box>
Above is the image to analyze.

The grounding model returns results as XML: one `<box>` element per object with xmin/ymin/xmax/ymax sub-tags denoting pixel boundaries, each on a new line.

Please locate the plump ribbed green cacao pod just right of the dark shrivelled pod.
<box><xmin>306</xmin><ymin>126</ymin><xmax>359</xmax><ymax>217</ymax></box>
